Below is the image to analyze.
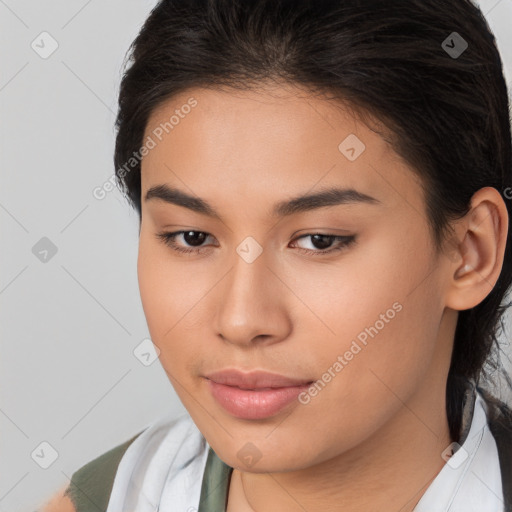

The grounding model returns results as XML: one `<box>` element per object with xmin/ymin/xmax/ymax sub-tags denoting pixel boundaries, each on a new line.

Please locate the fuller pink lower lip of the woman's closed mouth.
<box><xmin>207</xmin><ymin>379</ymin><xmax>311</xmax><ymax>420</ymax></box>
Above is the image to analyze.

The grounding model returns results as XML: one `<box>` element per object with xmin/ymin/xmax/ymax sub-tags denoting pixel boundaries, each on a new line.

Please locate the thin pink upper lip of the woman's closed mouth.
<box><xmin>205</xmin><ymin>368</ymin><xmax>313</xmax><ymax>389</ymax></box>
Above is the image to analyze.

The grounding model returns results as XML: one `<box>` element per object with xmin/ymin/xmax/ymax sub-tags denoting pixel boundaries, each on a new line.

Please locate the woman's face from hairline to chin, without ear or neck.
<box><xmin>138</xmin><ymin>86</ymin><xmax>450</xmax><ymax>472</ymax></box>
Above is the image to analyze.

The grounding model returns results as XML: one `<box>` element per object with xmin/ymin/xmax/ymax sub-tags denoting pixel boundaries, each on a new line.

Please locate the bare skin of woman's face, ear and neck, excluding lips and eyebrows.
<box><xmin>138</xmin><ymin>84</ymin><xmax>508</xmax><ymax>512</ymax></box>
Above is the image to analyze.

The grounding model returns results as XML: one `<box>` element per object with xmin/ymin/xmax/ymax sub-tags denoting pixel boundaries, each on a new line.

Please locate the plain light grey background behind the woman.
<box><xmin>0</xmin><ymin>0</ymin><xmax>512</xmax><ymax>512</ymax></box>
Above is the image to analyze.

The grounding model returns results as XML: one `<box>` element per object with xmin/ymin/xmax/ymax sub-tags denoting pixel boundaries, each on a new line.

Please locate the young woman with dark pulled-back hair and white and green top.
<box><xmin>46</xmin><ymin>0</ymin><xmax>512</xmax><ymax>512</ymax></box>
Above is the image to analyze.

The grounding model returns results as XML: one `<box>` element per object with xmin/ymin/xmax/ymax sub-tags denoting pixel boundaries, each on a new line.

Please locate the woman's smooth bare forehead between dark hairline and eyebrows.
<box><xmin>142</xmin><ymin>86</ymin><xmax>421</xmax><ymax>214</ymax></box>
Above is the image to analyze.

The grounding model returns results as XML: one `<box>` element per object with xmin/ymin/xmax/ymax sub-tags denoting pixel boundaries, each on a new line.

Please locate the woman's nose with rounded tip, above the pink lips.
<box><xmin>214</xmin><ymin>247</ymin><xmax>292</xmax><ymax>348</ymax></box>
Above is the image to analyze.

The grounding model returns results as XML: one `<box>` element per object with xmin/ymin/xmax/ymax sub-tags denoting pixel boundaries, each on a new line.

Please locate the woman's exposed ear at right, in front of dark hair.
<box><xmin>445</xmin><ymin>187</ymin><xmax>509</xmax><ymax>311</ymax></box>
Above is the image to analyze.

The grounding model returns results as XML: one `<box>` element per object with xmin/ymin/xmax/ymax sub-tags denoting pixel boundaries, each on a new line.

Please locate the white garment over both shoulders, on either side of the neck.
<box><xmin>106</xmin><ymin>392</ymin><xmax>504</xmax><ymax>512</ymax></box>
